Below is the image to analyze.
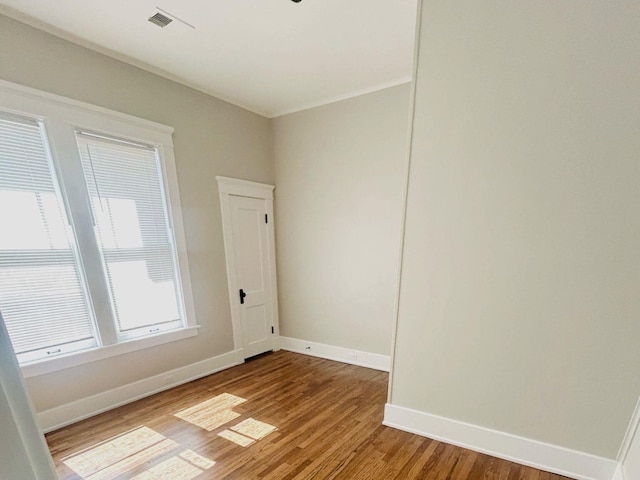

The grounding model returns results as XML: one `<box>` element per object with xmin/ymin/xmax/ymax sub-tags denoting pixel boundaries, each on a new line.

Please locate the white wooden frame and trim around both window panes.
<box><xmin>0</xmin><ymin>80</ymin><xmax>199</xmax><ymax>377</ymax></box>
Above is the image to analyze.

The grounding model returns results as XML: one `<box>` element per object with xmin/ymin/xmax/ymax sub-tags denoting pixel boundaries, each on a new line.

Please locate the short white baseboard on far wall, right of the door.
<box><xmin>280</xmin><ymin>337</ymin><xmax>391</xmax><ymax>372</ymax></box>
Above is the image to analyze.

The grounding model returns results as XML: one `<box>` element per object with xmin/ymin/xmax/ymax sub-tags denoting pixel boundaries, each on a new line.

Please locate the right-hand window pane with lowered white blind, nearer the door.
<box><xmin>77</xmin><ymin>133</ymin><xmax>183</xmax><ymax>337</ymax></box>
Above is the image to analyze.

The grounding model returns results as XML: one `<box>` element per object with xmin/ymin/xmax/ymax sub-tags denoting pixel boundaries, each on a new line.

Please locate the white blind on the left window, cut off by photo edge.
<box><xmin>0</xmin><ymin>114</ymin><xmax>97</xmax><ymax>362</ymax></box>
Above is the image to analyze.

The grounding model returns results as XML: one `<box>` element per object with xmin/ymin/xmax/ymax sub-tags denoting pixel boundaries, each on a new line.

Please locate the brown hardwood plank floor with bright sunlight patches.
<box><xmin>47</xmin><ymin>351</ymin><xmax>564</xmax><ymax>480</ymax></box>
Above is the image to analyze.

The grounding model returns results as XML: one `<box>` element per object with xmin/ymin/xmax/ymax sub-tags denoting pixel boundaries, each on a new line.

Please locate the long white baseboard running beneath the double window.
<box><xmin>37</xmin><ymin>350</ymin><xmax>244</xmax><ymax>433</ymax></box>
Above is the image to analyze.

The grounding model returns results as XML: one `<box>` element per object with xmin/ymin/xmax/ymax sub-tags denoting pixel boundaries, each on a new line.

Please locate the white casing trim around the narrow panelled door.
<box><xmin>216</xmin><ymin>176</ymin><xmax>280</xmax><ymax>362</ymax></box>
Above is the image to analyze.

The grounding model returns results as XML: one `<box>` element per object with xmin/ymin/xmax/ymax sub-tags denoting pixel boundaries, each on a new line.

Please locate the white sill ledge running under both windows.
<box><xmin>21</xmin><ymin>326</ymin><xmax>200</xmax><ymax>378</ymax></box>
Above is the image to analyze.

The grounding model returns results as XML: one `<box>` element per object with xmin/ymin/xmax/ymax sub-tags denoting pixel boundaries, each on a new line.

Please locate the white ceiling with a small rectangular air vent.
<box><xmin>0</xmin><ymin>0</ymin><xmax>417</xmax><ymax>117</ymax></box>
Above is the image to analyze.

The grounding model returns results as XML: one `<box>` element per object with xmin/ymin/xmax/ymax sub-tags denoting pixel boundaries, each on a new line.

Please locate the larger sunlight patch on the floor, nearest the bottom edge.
<box><xmin>63</xmin><ymin>426</ymin><xmax>215</xmax><ymax>480</ymax></box>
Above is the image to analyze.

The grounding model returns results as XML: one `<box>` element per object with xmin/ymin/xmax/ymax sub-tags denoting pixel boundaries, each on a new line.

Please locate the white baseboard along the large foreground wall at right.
<box><xmin>383</xmin><ymin>404</ymin><xmax>618</xmax><ymax>480</ymax></box>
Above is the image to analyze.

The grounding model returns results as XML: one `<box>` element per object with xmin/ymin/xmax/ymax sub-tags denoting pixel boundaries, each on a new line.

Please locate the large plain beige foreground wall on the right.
<box><xmin>391</xmin><ymin>0</ymin><xmax>640</xmax><ymax>458</ymax></box>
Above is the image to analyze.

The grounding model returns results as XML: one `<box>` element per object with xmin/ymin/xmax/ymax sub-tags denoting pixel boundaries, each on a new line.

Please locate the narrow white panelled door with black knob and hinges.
<box><xmin>229</xmin><ymin>195</ymin><xmax>273</xmax><ymax>358</ymax></box>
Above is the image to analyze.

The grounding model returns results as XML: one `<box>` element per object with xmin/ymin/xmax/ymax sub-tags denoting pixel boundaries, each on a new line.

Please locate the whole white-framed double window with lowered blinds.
<box><xmin>0</xmin><ymin>81</ymin><xmax>196</xmax><ymax>376</ymax></box>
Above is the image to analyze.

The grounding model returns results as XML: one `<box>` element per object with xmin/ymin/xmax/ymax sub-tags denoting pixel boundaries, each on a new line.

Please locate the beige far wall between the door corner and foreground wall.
<box><xmin>273</xmin><ymin>85</ymin><xmax>409</xmax><ymax>355</ymax></box>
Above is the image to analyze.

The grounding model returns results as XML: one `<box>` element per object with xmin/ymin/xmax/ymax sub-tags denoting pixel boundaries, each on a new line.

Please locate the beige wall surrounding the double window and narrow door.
<box><xmin>0</xmin><ymin>16</ymin><xmax>275</xmax><ymax>411</ymax></box>
